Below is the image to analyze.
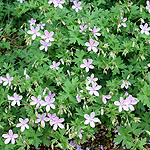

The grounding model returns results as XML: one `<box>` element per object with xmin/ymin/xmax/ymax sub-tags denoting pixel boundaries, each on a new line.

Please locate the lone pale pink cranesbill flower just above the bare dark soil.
<box><xmin>84</xmin><ymin>112</ymin><xmax>100</xmax><ymax>128</ymax></box>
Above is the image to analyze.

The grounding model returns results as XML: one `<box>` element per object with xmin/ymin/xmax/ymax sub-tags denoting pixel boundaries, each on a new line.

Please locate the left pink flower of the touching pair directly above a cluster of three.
<box><xmin>30</xmin><ymin>95</ymin><xmax>45</xmax><ymax>108</ymax></box>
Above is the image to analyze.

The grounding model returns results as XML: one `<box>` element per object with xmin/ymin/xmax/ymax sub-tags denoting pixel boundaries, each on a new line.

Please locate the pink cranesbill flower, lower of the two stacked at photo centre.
<box><xmin>86</xmin><ymin>83</ymin><xmax>102</xmax><ymax>96</ymax></box>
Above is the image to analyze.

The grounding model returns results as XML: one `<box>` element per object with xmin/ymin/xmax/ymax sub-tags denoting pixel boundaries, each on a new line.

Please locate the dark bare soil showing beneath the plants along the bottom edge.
<box><xmin>30</xmin><ymin>126</ymin><xmax>150</xmax><ymax>150</ymax></box>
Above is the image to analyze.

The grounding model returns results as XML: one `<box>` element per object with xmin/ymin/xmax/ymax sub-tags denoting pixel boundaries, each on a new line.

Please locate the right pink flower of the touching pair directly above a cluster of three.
<box><xmin>45</xmin><ymin>96</ymin><xmax>55</xmax><ymax>112</ymax></box>
